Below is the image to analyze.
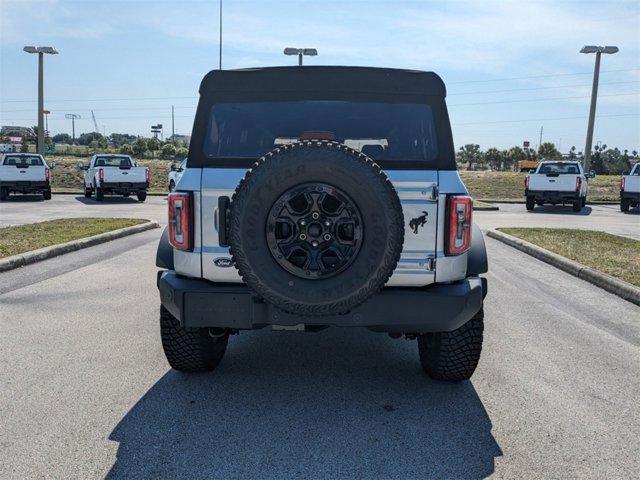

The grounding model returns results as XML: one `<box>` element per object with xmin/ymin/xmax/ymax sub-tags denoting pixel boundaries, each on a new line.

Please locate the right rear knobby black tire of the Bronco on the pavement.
<box><xmin>418</xmin><ymin>309</ymin><xmax>484</xmax><ymax>382</ymax></box>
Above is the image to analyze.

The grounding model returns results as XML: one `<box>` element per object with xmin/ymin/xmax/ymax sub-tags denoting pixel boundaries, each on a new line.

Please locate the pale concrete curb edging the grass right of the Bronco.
<box><xmin>487</xmin><ymin>230</ymin><xmax>640</xmax><ymax>305</ymax></box>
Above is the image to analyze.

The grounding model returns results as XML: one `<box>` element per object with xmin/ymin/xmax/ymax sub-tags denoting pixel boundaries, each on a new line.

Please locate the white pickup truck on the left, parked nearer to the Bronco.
<box><xmin>78</xmin><ymin>154</ymin><xmax>151</xmax><ymax>202</ymax></box>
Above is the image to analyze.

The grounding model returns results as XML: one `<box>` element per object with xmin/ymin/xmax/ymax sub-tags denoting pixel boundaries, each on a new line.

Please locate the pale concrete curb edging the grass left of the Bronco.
<box><xmin>0</xmin><ymin>222</ymin><xmax>159</xmax><ymax>272</ymax></box>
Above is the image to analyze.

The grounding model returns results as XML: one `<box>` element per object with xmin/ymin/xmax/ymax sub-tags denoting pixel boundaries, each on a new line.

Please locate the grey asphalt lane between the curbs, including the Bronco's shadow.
<box><xmin>0</xmin><ymin>231</ymin><xmax>640</xmax><ymax>479</ymax></box>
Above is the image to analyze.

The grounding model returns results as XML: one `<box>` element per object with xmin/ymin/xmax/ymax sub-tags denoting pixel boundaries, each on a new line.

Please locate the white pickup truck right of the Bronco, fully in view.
<box><xmin>524</xmin><ymin>161</ymin><xmax>596</xmax><ymax>212</ymax></box>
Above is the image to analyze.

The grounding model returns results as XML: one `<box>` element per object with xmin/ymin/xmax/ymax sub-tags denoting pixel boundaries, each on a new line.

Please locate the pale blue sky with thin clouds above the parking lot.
<box><xmin>0</xmin><ymin>0</ymin><xmax>640</xmax><ymax>151</ymax></box>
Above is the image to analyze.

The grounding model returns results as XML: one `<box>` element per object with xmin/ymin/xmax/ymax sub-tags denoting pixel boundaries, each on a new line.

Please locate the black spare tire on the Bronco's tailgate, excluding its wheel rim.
<box><xmin>228</xmin><ymin>141</ymin><xmax>402</xmax><ymax>316</ymax></box>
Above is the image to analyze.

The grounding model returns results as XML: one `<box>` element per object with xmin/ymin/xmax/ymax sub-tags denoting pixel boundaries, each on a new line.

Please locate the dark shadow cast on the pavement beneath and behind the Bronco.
<box><xmin>107</xmin><ymin>328</ymin><xmax>502</xmax><ymax>478</ymax></box>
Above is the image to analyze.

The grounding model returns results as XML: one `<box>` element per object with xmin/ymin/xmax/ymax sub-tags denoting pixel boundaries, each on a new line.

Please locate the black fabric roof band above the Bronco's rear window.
<box><xmin>200</xmin><ymin>66</ymin><xmax>446</xmax><ymax>101</ymax></box>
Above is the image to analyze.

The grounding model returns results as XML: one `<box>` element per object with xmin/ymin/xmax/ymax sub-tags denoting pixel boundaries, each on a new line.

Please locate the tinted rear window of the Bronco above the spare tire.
<box><xmin>203</xmin><ymin>100</ymin><xmax>438</xmax><ymax>162</ymax></box>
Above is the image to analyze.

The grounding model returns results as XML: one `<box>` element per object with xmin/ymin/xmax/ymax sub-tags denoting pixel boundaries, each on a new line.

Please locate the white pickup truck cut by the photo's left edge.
<box><xmin>0</xmin><ymin>153</ymin><xmax>55</xmax><ymax>200</ymax></box>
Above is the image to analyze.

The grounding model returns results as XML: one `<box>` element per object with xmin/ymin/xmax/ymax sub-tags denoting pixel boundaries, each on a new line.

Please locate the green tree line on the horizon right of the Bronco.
<box><xmin>456</xmin><ymin>142</ymin><xmax>640</xmax><ymax>175</ymax></box>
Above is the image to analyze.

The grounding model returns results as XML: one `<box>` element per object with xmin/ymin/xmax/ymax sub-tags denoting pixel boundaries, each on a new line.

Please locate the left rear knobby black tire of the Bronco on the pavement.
<box><xmin>160</xmin><ymin>306</ymin><xmax>229</xmax><ymax>373</ymax></box>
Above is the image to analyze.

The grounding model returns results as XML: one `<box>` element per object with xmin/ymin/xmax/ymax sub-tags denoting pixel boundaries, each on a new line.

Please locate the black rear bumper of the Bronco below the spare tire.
<box><xmin>158</xmin><ymin>270</ymin><xmax>487</xmax><ymax>333</ymax></box>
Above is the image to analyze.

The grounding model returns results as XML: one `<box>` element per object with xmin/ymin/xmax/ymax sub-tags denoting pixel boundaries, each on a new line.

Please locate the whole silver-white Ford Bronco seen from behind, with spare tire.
<box><xmin>156</xmin><ymin>66</ymin><xmax>487</xmax><ymax>381</ymax></box>
